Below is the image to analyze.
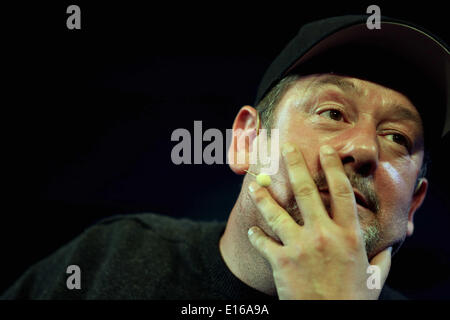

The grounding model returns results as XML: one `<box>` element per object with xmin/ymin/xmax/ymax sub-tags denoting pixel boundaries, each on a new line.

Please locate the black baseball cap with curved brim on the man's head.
<box><xmin>254</xmin><ymin>15</ymin><xmax>450</xmax><ymax>148</ymax></box>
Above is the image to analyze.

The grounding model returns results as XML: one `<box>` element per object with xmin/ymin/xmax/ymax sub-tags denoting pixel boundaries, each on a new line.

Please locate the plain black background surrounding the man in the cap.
<box><xmin>0</xmin><ymin>1</ymin><xmax>450</xmax><ymax>299</ymax></box>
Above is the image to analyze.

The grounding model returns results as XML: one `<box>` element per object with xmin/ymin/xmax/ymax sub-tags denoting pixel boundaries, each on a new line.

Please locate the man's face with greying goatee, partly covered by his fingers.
<box><xmin>258</xmin><ymin>74</ymin><xmax>423</xmax><ymax>258</ymax></box>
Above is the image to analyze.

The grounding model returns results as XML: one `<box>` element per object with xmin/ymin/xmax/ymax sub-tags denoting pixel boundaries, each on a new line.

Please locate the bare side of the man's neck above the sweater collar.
<box><xmin>219</xmin><ymin>181</ymin><xmax>276</xmax><ymax>295</ymax></box>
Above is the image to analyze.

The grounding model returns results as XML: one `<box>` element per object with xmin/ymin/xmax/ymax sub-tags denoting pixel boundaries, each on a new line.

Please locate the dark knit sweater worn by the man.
<box><xmin>1</xmin><ymin>214</ymin><xmax>404</xmax><ymax>300</ymax></box>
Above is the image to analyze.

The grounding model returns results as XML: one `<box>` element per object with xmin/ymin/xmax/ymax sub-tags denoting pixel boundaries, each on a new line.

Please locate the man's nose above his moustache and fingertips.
<box><xmin>336</xmin><ymin>124</ymin><xmax>379</xmax><ymax>176</ymax></box>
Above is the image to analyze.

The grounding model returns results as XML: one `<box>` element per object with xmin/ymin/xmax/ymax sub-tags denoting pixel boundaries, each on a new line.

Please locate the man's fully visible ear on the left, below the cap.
<box><xmin>228</xmin><ymin>106</ymin><xmax>260</xmax><ymax>174</ymax></box>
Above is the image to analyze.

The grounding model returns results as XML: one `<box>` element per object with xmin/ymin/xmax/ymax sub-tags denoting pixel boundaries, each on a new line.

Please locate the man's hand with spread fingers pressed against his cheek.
<box><xmin>249</xmin><ymin>144</ymin><xmax>391</xmax><ymax>300</ymax></box>
